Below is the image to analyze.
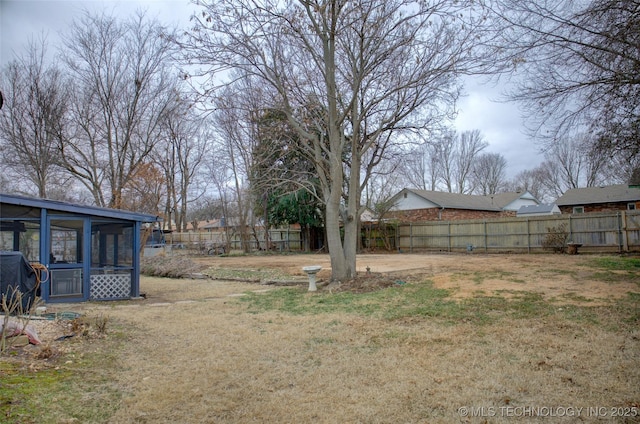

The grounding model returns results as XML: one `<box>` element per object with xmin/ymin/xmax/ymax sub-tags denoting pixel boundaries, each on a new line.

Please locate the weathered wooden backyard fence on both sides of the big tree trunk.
<box><xmin>162</xmin><ymin>211</ymin><xmax>640</xmax><ymax>253</ymax></box>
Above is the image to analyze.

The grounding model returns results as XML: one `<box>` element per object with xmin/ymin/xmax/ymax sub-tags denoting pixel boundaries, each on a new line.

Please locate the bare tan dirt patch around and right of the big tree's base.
<box><xmin>197</xmin><ymin>253</ymin><xmax>640</xmax><ymax>304</ymax></box>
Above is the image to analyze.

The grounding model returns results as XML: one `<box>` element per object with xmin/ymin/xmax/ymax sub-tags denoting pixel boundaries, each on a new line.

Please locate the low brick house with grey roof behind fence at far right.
<box><xmin>556</xmin><ymin>184</ymin><xmax>640</xmax><ymax>213</ymax></box>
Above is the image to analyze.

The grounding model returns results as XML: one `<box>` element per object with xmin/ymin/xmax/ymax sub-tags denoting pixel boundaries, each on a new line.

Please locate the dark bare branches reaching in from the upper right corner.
<box><xmin>487</xmin><ymin>0</ymin><xmax>640</xmax><ymax>160</ymax></box>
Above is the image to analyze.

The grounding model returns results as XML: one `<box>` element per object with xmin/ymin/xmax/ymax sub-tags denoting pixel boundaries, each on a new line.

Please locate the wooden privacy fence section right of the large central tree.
<box><xmin>396</xmin><ymin>211</ymin><xmax>640</xmax><ymax>252</ymax></box>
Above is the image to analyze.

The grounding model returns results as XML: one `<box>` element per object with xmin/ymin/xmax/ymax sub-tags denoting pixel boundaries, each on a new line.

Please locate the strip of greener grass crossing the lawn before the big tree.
<box><xmin>240</xmin><ymin>281</ymin><xmax>624</xmax><ymax>325</ymax></box>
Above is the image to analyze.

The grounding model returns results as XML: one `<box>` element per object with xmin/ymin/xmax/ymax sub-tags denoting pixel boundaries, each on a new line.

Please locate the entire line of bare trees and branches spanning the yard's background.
<box><xmin>0</xmin><ymin>0</ymin><xmax>640</xmax><ymax>279</ymax></box>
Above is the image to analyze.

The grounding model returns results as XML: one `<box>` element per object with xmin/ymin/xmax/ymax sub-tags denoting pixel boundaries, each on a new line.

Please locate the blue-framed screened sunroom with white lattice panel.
<box><xmin>0</xmin><ymin>194</ymin><xmax>158</xmax><ymax>303</ymax></box>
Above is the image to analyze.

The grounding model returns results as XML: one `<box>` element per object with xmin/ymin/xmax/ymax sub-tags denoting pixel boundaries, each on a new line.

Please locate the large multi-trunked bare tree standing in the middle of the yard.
<box><xmin>185</xmin><ymin>0</ymin><xmax>496</xmax><ymax>280</ymax></box>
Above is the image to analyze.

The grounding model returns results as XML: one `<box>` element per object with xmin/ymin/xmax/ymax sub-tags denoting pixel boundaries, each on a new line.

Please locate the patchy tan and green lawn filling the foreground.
<box><xmin>0</xmin><ymin>256</ymin><xmax>640</xmax><ymax>424</ymax></box>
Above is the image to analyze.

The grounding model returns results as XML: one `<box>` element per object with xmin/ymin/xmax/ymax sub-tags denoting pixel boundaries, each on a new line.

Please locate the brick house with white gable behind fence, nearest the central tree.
<box><xmin>385</xmin><ymin>188</ymin><xmax>539</xmax><ymax>222</ymax></box>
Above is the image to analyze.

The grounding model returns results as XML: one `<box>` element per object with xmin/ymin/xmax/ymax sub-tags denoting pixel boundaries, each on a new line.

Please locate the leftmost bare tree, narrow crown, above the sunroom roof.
<box><xmin>0</xmin><ymin>39</ymin><xmax>68</xmax><ymax>198</ymax></box>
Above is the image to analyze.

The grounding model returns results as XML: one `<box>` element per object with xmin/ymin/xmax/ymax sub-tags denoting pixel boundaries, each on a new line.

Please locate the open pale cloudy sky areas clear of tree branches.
<box><xmin>0</xmin><ymin>0</ymin><xmax>541</xmax><ymax>177</ymax></box>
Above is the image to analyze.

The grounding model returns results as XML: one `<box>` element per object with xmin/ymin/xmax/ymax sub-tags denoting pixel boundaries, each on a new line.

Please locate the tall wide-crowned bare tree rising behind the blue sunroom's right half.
<box><xmin>58</xmin><ymin>12</ymin><xmax>176</xmax><ymax>208</ymax></box>
